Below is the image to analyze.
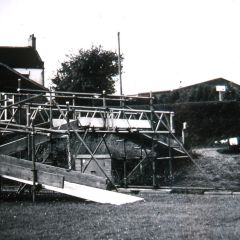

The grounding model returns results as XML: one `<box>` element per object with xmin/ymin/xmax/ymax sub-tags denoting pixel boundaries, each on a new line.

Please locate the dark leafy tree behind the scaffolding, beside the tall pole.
<box><xmin>52</xmin><ymin>46</ymin><xmax>123</xmax><ymax>94</ymax></box>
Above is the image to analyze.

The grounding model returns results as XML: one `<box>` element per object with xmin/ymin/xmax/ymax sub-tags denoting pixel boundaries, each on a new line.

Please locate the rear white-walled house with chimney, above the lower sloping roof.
<box><xmin>0</xmin><ymin>34</ymin><xmax>44</xmax><ymax>89</ymax></box>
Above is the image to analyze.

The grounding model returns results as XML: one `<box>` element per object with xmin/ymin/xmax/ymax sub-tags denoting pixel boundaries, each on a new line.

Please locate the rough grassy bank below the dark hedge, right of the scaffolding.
<box><xmin>174</xmin><ymin>148</ymin><xmax>240</xmax><ymax>191</ymax></box>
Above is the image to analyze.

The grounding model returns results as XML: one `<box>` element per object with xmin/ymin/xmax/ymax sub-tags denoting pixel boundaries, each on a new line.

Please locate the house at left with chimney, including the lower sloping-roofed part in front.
<box><xmin>0</xmin><ymin>34</ymin><xmax>48</xmax><ymax>123</ymax></box>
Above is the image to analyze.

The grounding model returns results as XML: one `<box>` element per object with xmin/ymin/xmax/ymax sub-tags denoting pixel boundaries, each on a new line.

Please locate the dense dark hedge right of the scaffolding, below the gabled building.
<box><xmin>171</xmin><ymin>101</ymin><xmax>240</xmax><ymax>147</ymax></box>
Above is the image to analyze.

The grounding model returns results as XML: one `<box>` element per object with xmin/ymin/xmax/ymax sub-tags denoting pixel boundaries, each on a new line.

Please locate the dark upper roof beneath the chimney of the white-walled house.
<box><xmin>0</xmin><ymin>47</ymin><xmax>44</xmax><ymax>68</ymax></box>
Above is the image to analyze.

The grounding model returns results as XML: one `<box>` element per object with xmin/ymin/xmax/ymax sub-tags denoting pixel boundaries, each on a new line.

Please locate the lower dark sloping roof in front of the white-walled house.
<box><xmin>0</xmin><ymin>63</ymin><xmax>48</xmax><ymax>92</ymax></box>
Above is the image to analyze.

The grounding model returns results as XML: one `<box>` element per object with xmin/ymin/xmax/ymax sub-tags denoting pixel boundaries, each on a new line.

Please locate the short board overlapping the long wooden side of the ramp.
<box><xmin>37</xmin><ymin>171</ymin><xmax>64</xmax><ymax>188</ymax></box>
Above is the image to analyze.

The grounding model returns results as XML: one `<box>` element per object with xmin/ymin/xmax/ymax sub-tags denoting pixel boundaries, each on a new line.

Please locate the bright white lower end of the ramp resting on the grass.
<box><xmin>43</xmin><ymin>181</ymin><xmax>143</xmax><ymax>205</ymax></box>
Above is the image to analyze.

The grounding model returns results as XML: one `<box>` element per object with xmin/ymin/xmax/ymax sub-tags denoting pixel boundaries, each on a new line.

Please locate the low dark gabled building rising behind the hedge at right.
<box><xmin>138</xmin><ymin>78</ymin><xmax>240</xmax><ymax>104</ymax></box>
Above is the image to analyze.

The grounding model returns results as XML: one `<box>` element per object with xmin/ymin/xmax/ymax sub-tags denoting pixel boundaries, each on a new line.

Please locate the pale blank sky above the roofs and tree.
<box><xmin>0</xmin><ymin>0</ymin><xmax>240</xmax><ymax>94</ymax></box>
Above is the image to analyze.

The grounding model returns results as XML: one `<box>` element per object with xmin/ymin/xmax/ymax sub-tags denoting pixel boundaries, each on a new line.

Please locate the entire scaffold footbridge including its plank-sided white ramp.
<box><xmin>0</xmin><ymin>88</ymin><xmax>190</xmax><ymax>204</ymax></box>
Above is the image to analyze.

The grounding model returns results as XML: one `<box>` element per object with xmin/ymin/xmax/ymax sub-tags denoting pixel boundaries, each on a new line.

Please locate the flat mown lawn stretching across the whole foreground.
<box><xmin>0</xmin><ymin>193</ymin><xmax>240</xmax><ymax>240</ymax></box>
